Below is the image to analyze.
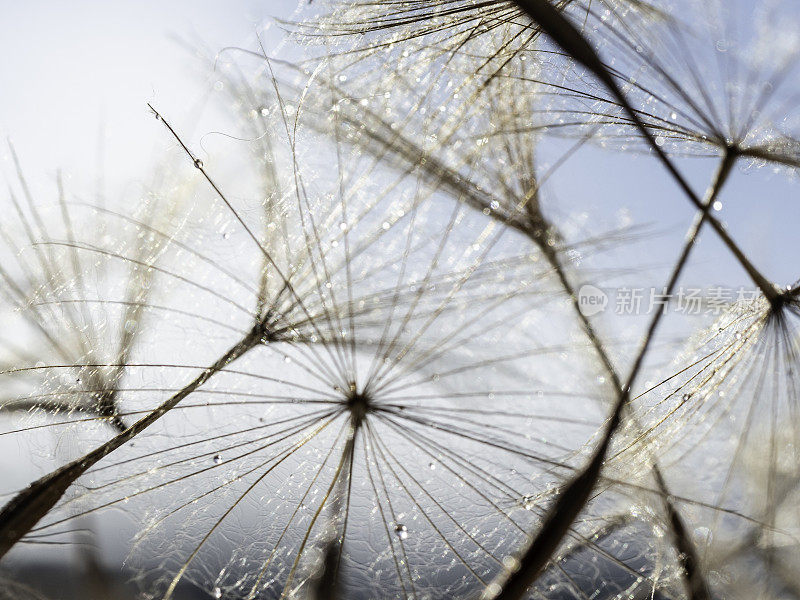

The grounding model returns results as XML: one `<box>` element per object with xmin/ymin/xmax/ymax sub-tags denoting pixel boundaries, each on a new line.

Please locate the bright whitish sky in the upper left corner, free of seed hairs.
<box><xmin>0</xmin><ymin>0</ymin><xmax>296</xmax><ymax>189</ymax></box>
